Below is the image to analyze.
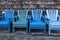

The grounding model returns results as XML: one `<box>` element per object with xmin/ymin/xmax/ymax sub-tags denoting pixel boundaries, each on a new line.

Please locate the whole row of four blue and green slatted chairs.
<box><xmin>0</xmin><ymin>9</ymin><xmax>60</xmax><ymax>35</ymax></box>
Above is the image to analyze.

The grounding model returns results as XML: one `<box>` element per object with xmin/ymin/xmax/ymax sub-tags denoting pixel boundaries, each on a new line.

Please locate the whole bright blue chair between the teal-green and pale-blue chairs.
<box><xmin>29</xmin><ymin>9</ymin><xmax>46</xmax><ymax>35</ymax></box>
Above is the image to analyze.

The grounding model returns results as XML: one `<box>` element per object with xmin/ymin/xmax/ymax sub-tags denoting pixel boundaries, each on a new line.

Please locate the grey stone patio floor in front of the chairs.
<box><xmin>0</xmin><ymin>30</ymin><xmax>60</xmax><ymax>40</ymax></box>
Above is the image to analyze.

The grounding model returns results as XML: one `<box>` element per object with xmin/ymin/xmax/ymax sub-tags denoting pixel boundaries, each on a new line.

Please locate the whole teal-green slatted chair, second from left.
<box><xmin>13</xmin><ymin>10</ymin><xmax>28</xmax><ymax>32</ymax></box>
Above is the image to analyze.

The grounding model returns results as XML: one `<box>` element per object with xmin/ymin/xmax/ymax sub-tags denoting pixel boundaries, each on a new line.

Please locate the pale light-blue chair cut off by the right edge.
<box><xmin>46</xmin><ymin>9</ymin><xmax>60</xmax><ymax>35</ymax></box>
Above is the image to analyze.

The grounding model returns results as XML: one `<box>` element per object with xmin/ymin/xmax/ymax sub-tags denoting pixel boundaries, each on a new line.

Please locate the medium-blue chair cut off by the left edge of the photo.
<box><xmin>0</xmin><ymin>9</ymin><xmax>14</xmax><ymax>32</ymax></box>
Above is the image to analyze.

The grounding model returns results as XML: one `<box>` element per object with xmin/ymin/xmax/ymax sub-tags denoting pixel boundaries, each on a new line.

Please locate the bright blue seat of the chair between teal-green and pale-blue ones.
<box><xmin>30</xmin><ymin>21</ymin><xmax>46</xmax><ymax>29</ymax></box>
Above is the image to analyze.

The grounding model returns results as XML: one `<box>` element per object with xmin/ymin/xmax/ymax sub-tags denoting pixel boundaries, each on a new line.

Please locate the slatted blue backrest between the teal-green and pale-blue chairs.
<box><xmin>32</xmin><ymin>9</ymin><xmax>43</xmax><ymax>21</ymax></box>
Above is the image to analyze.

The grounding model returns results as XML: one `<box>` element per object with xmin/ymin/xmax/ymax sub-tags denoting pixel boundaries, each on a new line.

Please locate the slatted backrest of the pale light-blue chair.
<box><xmin>46</xmin><ymin>9</ymin><xmax>58</xmax><ymax>21</ymax></box>
